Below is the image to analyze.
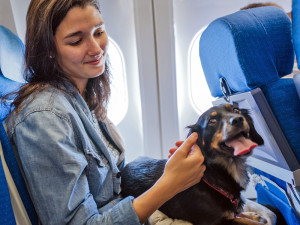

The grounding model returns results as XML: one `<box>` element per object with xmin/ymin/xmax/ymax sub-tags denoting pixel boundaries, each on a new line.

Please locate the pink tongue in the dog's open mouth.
<box><xmin>225</xmin><ymin>135</ymin><xmax>258</xmax><ymax>156</ymax></box>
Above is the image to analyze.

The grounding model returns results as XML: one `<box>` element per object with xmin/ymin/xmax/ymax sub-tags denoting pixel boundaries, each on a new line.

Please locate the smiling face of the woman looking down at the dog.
<box><xmin>54</xmin><ymin>5</ymin><xmax>108</xmax><ymax>94</ymax></box>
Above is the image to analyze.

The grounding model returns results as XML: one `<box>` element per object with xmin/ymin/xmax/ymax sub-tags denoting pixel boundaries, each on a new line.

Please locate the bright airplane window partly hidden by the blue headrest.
<box><xmin>188</xmin><ymin>26</ymin><xmax>214</xmax><ymax>114</ymax></box>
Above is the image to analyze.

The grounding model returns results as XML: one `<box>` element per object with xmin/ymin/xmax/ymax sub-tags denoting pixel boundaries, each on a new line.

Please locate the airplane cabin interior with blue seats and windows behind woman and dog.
<box><xmin>0</xmin><ymin>0</ymin><xmax>300</xmax><ymax>225</ymax></box>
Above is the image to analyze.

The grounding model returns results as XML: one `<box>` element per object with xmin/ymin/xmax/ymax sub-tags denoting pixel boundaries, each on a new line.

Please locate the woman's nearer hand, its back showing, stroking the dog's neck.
<box><xmin>160</xmin><ymin>133</ymin><xmax>206</xmax><ymax>198</ymax></box>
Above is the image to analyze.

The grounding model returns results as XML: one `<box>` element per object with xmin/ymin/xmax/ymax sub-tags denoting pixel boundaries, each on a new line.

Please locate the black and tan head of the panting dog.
<box><xmin>189</xmin><ymin>104</ymin><xmax>264</xmax><ymax>162</ymax></box>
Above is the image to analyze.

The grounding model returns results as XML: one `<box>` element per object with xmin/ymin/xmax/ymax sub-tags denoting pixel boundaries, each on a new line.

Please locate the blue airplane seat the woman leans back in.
<box><xmin>0</xmin><ymin>26</ymin><xmax>38</xmax><ymax>225</ymax></box>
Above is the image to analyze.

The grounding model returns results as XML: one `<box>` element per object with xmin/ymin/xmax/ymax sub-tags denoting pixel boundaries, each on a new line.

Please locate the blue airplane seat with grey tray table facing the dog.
<box><xmin>199</xmin><ymin>6</ymin><xmax>300</xmax><ymax>224</ymax></box>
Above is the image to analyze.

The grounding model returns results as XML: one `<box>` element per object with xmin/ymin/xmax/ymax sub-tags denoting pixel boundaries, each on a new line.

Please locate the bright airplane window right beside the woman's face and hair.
<box><xmin>107</xmin><ymin>38</ymin><xmax>128</xmax><ymax>125</ymax></box>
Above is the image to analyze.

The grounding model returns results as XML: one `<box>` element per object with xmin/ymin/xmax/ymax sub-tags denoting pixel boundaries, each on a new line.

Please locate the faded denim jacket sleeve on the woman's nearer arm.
<box><xmin>13</xmin><ymin>111</ymin><xmax>140</xmax><ymax>225</ymax></box>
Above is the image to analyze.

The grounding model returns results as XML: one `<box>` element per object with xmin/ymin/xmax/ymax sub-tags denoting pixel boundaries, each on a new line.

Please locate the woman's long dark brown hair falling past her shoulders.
<box><xmin>12</xmin><ymin>0</ymin><xmax>110</xmax><ymax>120</ymax></box>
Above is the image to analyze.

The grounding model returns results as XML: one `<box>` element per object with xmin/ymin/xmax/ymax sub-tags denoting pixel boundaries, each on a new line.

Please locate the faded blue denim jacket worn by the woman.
<box><xmin>4</xmin><ymin>85</ymin><xmax>140</xmax><ymax>225</ymax></box>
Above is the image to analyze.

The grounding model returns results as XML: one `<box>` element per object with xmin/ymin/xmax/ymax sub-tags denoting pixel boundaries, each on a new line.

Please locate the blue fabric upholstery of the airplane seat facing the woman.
<box><xmin>199</xmin><ymin>5</ymin><xmax>300</xmax><ymax>225</ymax></box>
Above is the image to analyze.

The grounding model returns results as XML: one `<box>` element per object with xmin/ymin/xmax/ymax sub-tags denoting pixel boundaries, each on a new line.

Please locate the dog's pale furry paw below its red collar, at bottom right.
<box><xmin>243</xmin><ymin>199</ymin><xmax>277</xmax><ymax>225</ymax></box>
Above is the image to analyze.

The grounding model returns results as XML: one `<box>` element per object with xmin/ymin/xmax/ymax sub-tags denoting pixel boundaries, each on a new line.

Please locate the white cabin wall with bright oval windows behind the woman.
<box><xmin>0</xmin><ymin>0</ymin><xmax>291</xmax><ymax>161</ymax></box>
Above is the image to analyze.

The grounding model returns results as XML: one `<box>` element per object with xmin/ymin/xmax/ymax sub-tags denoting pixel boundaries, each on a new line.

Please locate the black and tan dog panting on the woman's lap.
<box><xmin>121</xmin><ymin>104</ymin><xmax>263</xmax><ymax>225</ymax></box>
